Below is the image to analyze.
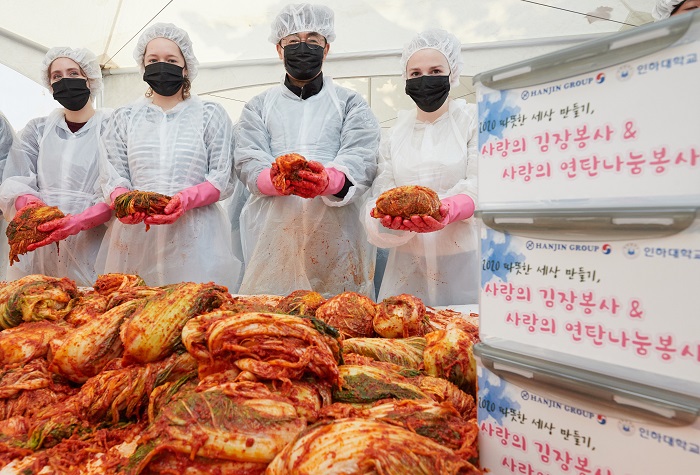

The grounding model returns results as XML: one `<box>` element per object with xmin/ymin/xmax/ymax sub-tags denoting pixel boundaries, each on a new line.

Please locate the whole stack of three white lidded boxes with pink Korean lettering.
<box><xmin>474</xmin><ymin>11</ymin><xmax>700</xmax><ymax>475</ymax></box>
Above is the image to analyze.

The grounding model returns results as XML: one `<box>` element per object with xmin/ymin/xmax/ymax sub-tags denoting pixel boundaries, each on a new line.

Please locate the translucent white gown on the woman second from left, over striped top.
<box><xmin>98</xmin><ymin>94</ymin><xmax>241</xmax><ymax>292</ymax></box>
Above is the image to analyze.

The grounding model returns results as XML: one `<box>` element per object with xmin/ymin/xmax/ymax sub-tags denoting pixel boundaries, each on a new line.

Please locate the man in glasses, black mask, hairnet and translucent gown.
<box><xmin>234</xmin><ymin>4</ymin><xmax>380</xmax><ymax>298</ymax></box>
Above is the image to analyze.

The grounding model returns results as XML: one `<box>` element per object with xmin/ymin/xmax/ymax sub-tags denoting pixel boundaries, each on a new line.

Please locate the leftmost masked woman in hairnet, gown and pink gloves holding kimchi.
<box><xmin>0</xmin><ymin>47</ymin><xmax>112</xmax><ymax>286</ymax></box>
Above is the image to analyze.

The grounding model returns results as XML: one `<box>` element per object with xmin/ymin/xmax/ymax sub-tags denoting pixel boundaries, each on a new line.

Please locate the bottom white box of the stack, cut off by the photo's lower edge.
<box><xmin>477</xmin><ymin>346</ymin><xmax>700</xmax><ymax>475</ymax></box>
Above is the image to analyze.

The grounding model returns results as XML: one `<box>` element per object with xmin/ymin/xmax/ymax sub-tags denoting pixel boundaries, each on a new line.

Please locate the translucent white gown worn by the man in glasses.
<box><xmin>234</xmin><ymin>77</ymin><xmax>380</xmax><ymax>297</ymax></box>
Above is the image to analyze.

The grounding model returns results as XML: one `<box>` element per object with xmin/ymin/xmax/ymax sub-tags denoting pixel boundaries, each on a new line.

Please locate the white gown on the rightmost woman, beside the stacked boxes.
<box><xmin>362</xmin><ymin>100</ymin><xmax>479</xmax><ymax>306</ymax></box>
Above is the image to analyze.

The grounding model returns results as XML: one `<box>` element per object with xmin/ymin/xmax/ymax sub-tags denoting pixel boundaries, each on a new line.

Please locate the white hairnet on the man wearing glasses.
<box><xmin>269</xmin><ymin>3</ymin><xmax>335</xmax><ymax>44</ymax></box>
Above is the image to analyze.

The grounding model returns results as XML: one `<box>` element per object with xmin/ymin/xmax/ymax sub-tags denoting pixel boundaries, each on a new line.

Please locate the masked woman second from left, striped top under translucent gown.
<box><xmin>99</xmin><ymin>23</ymin><xmax>241</xmax><ymax>292</ymax></box>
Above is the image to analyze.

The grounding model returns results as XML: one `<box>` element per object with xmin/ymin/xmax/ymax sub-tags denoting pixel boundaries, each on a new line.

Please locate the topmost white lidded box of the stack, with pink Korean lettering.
<box><xmin>474</xmin><ymin>14</ymin><xmax>700</xmax><ymax>210</ymax></box>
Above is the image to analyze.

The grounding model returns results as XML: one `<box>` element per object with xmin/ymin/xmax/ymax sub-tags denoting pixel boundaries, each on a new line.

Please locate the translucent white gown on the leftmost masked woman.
<box><xmin>0</xmin><ymin>109</ymin><xmax>111</xmax><ymax>286</ymax></box>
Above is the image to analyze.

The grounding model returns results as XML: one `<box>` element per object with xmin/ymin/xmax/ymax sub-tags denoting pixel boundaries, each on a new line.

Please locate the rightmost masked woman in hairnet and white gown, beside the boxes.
<box><xmin>362</xmin><ymin>30</ymin><xmax>479</xmax><ymax>306</ymax></box>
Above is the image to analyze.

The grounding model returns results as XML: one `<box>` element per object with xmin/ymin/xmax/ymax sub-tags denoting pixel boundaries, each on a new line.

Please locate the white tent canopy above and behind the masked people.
<box><xmin>0</xmin><ymin>0</ymin><xmax>655</xmax><ymax>126</ymax></box>
